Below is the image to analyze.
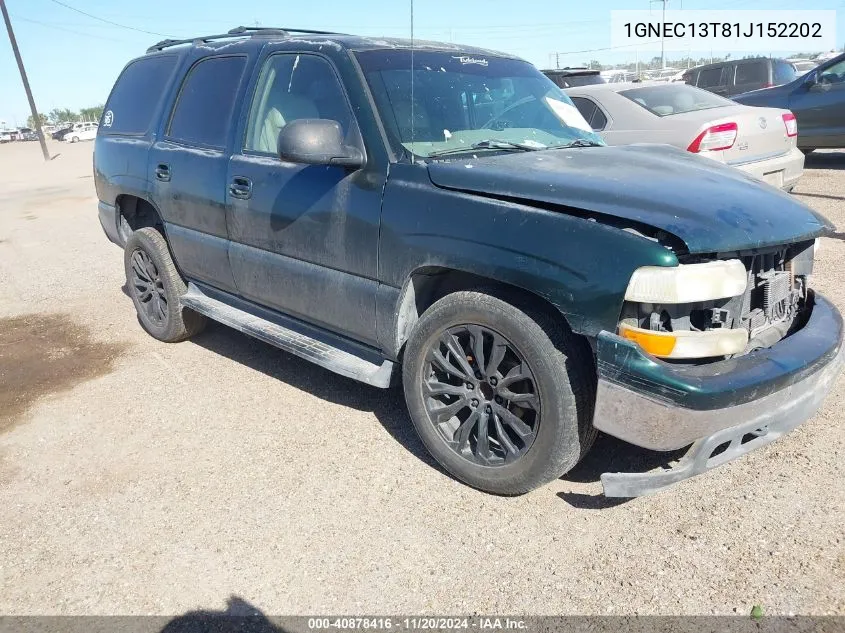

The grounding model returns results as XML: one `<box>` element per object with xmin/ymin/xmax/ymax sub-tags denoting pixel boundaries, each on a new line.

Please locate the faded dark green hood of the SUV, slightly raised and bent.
<box><xmin>428</xmin><ymin>145</ymin><xmax>832</xmax><ymax>253</ymax></box>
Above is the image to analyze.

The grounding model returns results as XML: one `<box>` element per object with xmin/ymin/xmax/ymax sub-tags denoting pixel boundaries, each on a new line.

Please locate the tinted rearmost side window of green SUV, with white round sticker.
<box><xmin>102</xmin><ymin>55</ymin><xmax>176</xmax><ymax>134</ymax></box>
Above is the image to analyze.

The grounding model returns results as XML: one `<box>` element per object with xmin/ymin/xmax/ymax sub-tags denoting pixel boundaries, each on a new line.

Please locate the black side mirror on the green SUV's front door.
<box><xmin>278</xmin><ymin>119</ymin><xmax>364</xmax><ymax>168</ymax></box>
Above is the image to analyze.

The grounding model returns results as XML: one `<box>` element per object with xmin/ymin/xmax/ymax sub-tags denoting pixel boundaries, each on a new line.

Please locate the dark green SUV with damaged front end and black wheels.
<box><xmin>94</xmin><ymin>28</ymin><xmax>845</xmax><ymax>497</ymax></box>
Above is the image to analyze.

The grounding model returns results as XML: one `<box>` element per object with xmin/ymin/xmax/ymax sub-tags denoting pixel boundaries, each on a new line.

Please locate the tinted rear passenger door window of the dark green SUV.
<box><xmin>167</xmin><ymin>55</ymin><xmax>247</xmax><ymax>148</ymax></box>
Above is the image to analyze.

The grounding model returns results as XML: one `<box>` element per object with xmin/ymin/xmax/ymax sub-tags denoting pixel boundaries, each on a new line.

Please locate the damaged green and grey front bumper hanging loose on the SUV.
<box><xmin>593</xmin><ymin>294</ymin><xmax>845</xmax><ymax>497</ymax></box>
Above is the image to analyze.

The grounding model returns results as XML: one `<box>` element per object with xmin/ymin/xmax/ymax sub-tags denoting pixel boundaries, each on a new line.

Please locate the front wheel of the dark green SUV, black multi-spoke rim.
<box><xmin>403</xmin><ymin>291</ymin><xmax>597</xmax><ymax>495</ymax></box>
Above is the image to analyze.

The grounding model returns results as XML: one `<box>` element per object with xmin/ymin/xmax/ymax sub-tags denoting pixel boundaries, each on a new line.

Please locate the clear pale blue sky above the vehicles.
<box><xmin>0</xmin><ymin>0</ymin><xmax>845</xmax><ymax>127</ymax></box>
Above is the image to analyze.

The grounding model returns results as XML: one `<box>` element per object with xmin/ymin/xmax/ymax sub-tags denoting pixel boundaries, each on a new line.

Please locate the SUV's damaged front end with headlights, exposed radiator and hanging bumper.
<box><xmin>594</xmin><ymin>230</ymin><xmax>845</xmax><ymax>496</ymax></box>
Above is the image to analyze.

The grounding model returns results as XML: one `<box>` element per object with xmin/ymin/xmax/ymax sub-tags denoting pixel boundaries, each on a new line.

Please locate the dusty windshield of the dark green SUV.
<box><xmin>357</xmin><ymin>50</ymin><xmax>603</xmax><ymax>157</ymax></box>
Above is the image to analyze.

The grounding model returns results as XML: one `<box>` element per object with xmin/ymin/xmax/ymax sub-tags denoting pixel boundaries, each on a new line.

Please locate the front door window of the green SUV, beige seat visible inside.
<box><xmin>244</xmin><ymin>53</ymin><xmax>352</xmax><ymax>155</ymax></box>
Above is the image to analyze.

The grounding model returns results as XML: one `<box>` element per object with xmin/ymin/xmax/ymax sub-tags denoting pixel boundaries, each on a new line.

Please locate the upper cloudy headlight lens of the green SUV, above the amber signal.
<box><xmin>625</xmin><ymin>259</ymin><xmax>748</xmax><ymax>303</ymax></box>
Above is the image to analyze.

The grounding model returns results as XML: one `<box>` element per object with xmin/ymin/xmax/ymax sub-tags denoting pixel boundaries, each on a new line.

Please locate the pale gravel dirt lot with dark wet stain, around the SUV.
<box><xmin>0</xmin><ymin>143</ymin><xmax>845</xmax><ymax>614</ymax></box>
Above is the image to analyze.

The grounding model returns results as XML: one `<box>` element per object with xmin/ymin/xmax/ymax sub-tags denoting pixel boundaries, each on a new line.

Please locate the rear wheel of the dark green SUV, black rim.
<box><xmin>123</xmin><ymin>228</ymin><xmax>206</xmax><ymax>343</ymax></box>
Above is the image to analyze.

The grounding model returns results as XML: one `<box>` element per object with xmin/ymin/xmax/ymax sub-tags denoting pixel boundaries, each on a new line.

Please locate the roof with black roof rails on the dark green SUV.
<box><xmin>142</xmin><ymin>26</ymin><xmax>520</xmax><ymax>59</ymax></box>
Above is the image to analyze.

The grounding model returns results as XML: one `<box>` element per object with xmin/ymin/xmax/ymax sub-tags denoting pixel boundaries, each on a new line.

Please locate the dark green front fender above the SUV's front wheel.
<box><xmin>379</xmin><ymin>165</ymin><xmax>678</xmax><ymax>337</ymax></box>
